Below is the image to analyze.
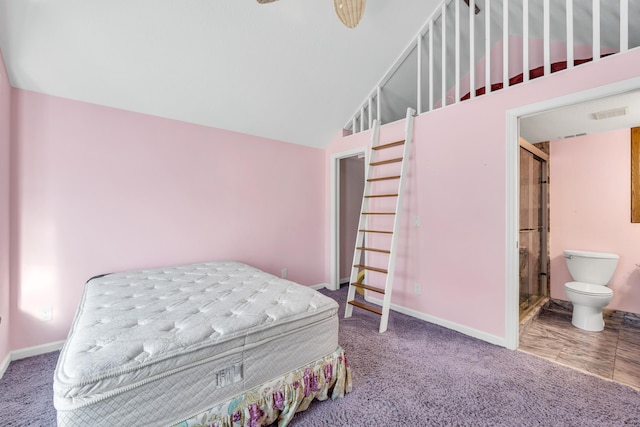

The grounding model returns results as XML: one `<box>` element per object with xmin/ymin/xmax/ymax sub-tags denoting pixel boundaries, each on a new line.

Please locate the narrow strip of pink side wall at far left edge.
<box><xmin>0</xmin><ymin>52</ymin><xmax>11</xmax><ymax>365</ymax></box>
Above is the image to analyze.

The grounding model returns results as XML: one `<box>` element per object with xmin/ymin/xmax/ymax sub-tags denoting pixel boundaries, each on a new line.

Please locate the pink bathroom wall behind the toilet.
<box><xmin>549</xmin><ymin>129</ymin><xmax>640</xmax><ymax>313</ymax></box>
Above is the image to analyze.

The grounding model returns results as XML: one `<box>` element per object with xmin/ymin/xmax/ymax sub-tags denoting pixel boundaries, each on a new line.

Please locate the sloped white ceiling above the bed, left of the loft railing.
<box><xmin>0</xmin><ymin>0</ymin><xmax>440</xmax><ymax>148</ymax></box>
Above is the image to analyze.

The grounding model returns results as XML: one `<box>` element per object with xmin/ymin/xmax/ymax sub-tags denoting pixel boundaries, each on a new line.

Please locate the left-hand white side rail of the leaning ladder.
<box><xmin>344</xmin><ymin>119</ymin><xmax>380</xmax><ymax>318</ymax></box>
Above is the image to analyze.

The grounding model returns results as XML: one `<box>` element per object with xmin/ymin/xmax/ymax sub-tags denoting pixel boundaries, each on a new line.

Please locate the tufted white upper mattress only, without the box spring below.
<box><xmin>54</xmin><ymin>261</ymin><xmax>338</xmax><ymax>410</ymax></box>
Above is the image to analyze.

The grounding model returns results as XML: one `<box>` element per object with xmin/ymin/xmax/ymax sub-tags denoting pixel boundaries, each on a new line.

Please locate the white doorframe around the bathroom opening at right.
<box><xmin>505</xmin><ymin>77</ymin><xmax>640</xmax><ymax>350</ymax></box>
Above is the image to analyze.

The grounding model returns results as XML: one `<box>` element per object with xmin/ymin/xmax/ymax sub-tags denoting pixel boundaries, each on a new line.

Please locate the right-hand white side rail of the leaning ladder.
<box><xmin>379</xmin><ymin>108</ymin><xmax>416</xmax><ymax>333</ymax></box>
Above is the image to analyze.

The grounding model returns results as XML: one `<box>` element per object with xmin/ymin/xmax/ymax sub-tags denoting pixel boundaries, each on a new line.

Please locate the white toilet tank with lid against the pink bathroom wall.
<box><xmin>563</xmin><ymin>250</ymin><xmax>620</xmax><ymax>286</ymax></box>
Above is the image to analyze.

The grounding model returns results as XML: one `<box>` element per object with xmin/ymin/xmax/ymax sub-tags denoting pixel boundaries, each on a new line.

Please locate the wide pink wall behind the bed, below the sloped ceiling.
<box><xmin>11</xmin><ymin>89</ymin><xmax>326</xmax><ymax>349</ymax></box>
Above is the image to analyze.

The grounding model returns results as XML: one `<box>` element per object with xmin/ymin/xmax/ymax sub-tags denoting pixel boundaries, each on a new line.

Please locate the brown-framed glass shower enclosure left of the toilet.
<box><xmin>519</xmin><ymin>139</ymin><xmax>550</xmax><ymax>321</ymax></box>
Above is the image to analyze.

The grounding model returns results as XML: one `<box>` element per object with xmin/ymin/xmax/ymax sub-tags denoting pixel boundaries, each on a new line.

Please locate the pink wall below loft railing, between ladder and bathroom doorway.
<box><xmin>327</xmin><ymin>49</ymin><xmax>640</xmax><ymax>338</ymax></box>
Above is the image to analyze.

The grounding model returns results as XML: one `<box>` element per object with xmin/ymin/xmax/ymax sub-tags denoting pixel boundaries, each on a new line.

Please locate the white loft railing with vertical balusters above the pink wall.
<box><xmin>345</xmin><ymin>0</ymin><xmax>640</xmax><ymax>133</ymax></box>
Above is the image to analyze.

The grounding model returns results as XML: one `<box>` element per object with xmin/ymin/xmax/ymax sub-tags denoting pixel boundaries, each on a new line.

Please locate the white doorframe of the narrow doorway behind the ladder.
<box><xmin>329</xmin><ymin>147</ymin><xmax>369</xmax><ymax>291</ymax></box>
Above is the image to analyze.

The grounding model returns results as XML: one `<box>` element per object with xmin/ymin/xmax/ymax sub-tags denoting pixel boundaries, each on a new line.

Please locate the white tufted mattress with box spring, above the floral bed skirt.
<box><xmin>54</xmin><ymin>262</ymin><xmax>338</xmax><ymax>426</ymax></box>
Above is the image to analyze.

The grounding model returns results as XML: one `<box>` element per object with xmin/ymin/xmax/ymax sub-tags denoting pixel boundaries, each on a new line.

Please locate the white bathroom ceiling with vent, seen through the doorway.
<box><xmin>520</xmin><ymin>91</ymin><xmax>640</xmax><ymax>144</ymax></box>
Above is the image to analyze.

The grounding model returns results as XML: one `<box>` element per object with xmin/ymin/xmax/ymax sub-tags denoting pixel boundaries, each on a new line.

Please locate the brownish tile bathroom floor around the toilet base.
<box><xmin>518</xmin><ymin>308</ymin><xmax>640</xmax><ymax>389</ymax></box>
